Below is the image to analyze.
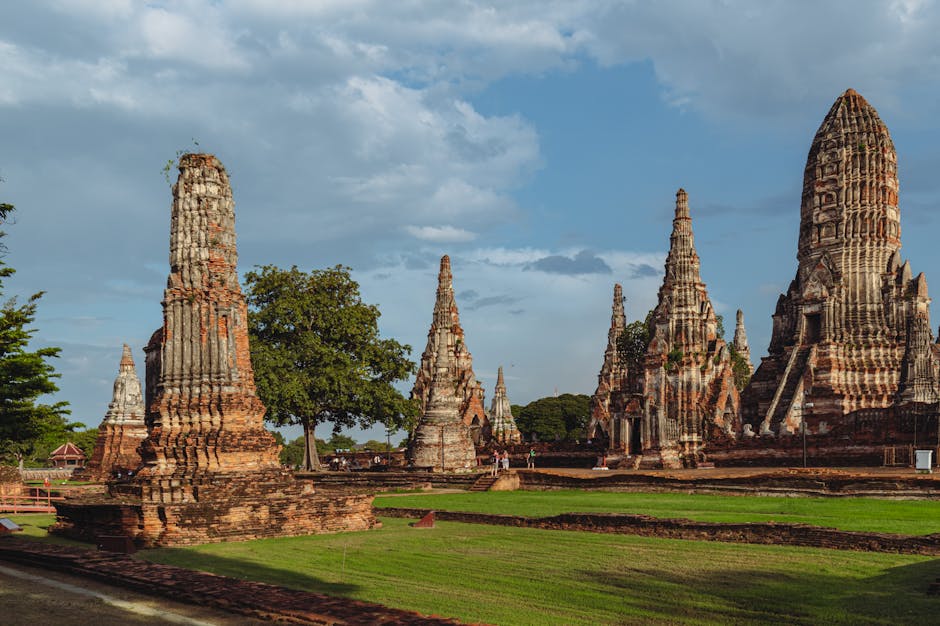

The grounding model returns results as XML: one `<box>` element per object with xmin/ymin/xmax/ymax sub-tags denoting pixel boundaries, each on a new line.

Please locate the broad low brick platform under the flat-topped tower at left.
<box><xmin>50</xmin><ymin>473</ymin><xmax>379</xmax><ymax>548</ymax></box>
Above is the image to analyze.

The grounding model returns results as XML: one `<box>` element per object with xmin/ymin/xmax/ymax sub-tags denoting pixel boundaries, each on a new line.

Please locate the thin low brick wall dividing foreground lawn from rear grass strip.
<box><xmin>376</xmin><ymin>507</ymin><xmax>940</xmax><ymax>556</ymax></box>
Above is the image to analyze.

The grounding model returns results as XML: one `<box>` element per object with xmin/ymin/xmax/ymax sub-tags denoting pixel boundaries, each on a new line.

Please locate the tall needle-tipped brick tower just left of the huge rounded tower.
<box><xmin>641</xmin><ymin>189</ymin><xmax>740</xmax><ymax>467</ymax></box>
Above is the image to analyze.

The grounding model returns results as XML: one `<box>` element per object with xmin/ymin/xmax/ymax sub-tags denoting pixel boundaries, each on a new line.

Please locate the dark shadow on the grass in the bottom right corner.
<box><xmin>582</xmin><ymin>556</ymin><xmax>940</xmax><ymax>624</ymax></box>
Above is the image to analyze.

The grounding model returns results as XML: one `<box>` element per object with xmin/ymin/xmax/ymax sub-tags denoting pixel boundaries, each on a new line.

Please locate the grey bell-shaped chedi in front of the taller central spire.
<box><xmin>408</xmin><ymin>316</ymin><xmax>476</xmax><ymax>472</ymax></box>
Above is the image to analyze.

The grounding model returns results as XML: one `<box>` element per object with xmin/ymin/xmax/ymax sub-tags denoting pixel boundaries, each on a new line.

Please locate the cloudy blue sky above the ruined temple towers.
<box><xmin>0</xmin><ymin>0</ymin><xmax>940</xmax><ymax>440</ymax></box>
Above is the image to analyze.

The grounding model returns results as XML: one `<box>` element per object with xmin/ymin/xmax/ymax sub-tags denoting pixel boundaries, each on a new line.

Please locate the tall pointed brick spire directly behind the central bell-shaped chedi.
<box><xmin>411</xmin><ymin>255</ymin><xmax>491</xmax><ymax>443</ymax></box>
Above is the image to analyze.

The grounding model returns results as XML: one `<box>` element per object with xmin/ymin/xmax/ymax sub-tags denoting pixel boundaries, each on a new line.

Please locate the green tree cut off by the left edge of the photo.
<box><xmin>0</xmin><ymin>203</ymin><xmax>69</xmax><ymax>464</ymax></box>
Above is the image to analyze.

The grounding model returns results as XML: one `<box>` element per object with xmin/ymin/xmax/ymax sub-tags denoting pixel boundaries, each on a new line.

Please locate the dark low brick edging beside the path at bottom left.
<box><xmin>0</xmin><ymin>537</ymin><xmax>460</xmax><ymax>625</ymax></box>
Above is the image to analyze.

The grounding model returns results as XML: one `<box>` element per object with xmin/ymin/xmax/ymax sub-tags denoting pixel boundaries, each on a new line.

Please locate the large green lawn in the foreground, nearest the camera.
<box><xmin>138</xmin><ymin>518</ymin><xmax>940</xmax><ymax>625</ymax></box>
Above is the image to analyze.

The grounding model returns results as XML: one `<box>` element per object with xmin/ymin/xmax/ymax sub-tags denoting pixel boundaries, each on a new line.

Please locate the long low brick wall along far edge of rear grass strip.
<box><xmin>518</xmin><ymin>470</ymin><xmax>940</xmax><ymax>499</ymax></box>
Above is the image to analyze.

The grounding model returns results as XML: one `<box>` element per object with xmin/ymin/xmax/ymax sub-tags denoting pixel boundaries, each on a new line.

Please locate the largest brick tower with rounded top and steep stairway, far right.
<box><xmin>742</xmin><ymin>89</ymin><xmax>937</xmax><ymax>443</ymax></box>
